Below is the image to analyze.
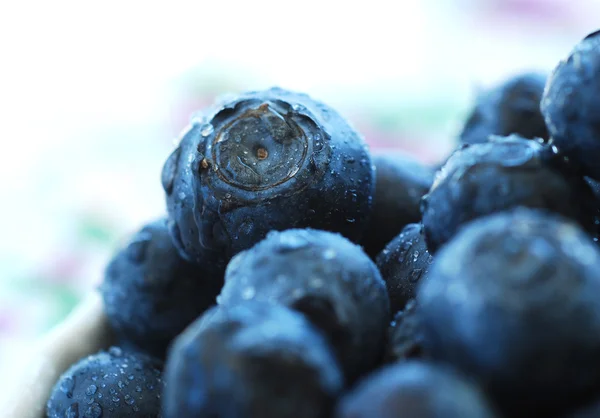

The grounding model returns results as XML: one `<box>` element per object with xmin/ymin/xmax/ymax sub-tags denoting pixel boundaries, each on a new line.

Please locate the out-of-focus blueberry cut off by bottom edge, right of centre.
<box><xmin>335</xmin><ymin>360</ymin><xmax>495</xmax><ymax>418</ymax></box>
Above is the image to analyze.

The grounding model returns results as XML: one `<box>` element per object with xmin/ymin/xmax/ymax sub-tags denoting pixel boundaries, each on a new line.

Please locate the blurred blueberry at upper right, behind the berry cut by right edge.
<box><xmin>459</xmin><ymin>72</ymin><xmax>549</xmax><ymax>144</ymax></box>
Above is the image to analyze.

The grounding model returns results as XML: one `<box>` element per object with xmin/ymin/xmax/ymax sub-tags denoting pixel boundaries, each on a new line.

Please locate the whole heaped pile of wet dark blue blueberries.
<box><xmin>47</xmin><ymin>32</ymin><xmax>600</xmax><ymax>418</ymax></box>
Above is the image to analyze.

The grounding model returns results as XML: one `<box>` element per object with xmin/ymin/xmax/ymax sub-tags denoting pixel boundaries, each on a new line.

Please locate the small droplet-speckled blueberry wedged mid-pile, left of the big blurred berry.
<box><xmin>376</xmin><ymin>224</ymin><xmax>433</xmax><ymax>312</ymax></box>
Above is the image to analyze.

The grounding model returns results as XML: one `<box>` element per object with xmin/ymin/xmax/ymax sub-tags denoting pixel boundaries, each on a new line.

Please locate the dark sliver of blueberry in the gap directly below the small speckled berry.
<box><xmin>385</xmin><ymin>299</ymin><xmax>424</xmax><ymax>363</ymax></box>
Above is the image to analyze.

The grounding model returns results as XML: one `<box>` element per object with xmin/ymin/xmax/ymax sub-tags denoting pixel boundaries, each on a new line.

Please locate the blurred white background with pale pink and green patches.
<box><xmin>0</xmin><ymin>0</ymin><xmax>600</xmax><ymax>378</ymax></box>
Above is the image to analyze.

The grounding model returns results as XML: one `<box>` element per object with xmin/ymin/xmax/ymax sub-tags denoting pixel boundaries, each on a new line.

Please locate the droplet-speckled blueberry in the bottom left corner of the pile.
<box><xmin>47</xmin><ymin>347</ymin><xmax>164</xmax><ymax>418</ymax></box>
